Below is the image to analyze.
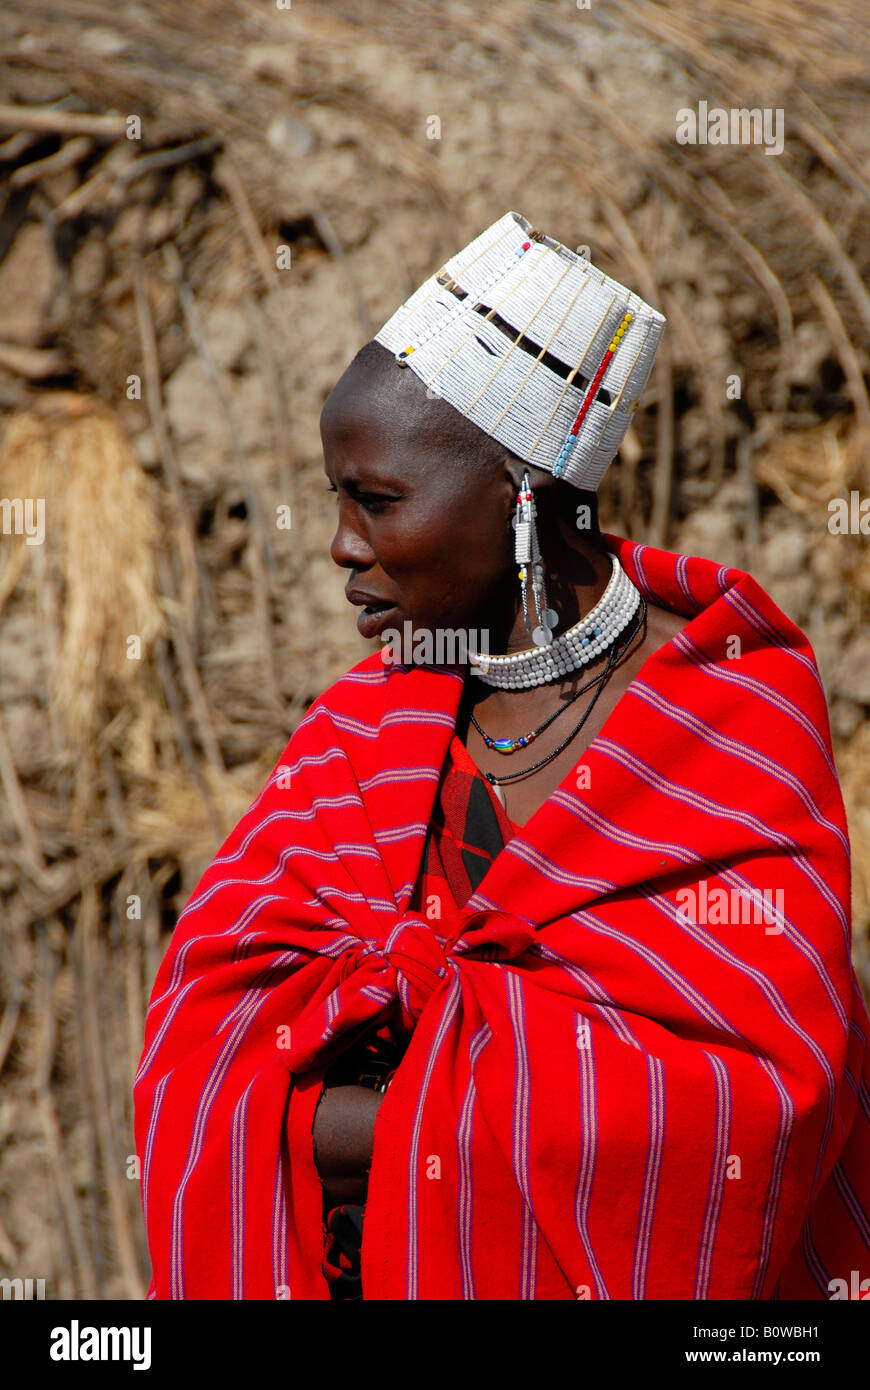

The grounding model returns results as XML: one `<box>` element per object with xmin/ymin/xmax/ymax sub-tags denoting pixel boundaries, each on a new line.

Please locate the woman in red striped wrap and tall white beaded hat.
<box><xmin>136</xmin><ymin>214</ymin><xmax>870</xmax><ymax>1300</ymax></box>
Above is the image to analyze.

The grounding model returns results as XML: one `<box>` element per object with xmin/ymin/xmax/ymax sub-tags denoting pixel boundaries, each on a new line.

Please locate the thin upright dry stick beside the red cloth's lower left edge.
<box><xmin>75</xmin><ymin>883</ymin><xmax>145</xmax><ymax>1300</ymax></box>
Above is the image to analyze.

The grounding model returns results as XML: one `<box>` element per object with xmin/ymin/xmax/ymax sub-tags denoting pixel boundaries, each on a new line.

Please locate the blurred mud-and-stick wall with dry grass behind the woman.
<box><xmin>0</xmin><ymin>0</ymin><xmax>870</xmax><ymax>1298</ymax></box>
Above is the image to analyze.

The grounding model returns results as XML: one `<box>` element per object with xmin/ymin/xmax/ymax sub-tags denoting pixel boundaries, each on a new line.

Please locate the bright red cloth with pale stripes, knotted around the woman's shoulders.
<box><xmin>135</xmin><ymin>537</ymin><xmax>870</xmax><ymax>1300</ymax></box>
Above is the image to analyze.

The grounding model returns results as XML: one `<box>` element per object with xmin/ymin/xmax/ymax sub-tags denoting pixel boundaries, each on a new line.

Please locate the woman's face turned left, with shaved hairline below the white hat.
<box><xmin>321</xmin><ymin>352</ymin><xmax>516</xmax><ymax>651</ymax></box>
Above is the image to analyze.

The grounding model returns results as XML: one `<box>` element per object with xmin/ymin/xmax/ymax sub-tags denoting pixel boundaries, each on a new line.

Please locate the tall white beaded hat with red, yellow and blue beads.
<box><xmin>375</xmin><ymin>205</ymin><xmax>666</xmax><ymax>491</ymax></box>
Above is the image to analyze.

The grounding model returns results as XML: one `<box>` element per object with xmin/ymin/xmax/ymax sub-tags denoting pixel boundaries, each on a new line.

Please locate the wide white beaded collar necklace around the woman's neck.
<box><xmin>468</xmin><ymin>555</ymin><xmax>641</xmax><ymax>689</ymax></box>
